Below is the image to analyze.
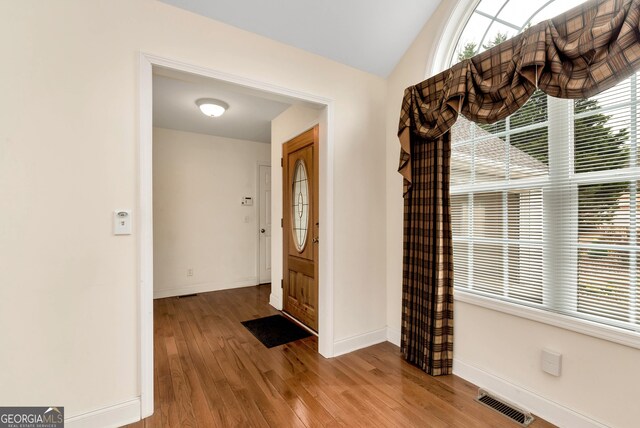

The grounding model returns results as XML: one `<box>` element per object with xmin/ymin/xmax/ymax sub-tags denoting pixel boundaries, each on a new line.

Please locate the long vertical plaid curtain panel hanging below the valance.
<box><xmin>402</xmin><ymin>132</ymin><xmax>453</xmax><ymax>376</ymax></box>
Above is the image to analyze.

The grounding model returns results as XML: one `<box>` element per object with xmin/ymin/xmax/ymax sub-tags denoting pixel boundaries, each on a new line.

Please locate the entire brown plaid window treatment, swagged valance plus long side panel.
<box><xmin>398</xmin><ymin>0</ymin><xmax>640</xmax><ymax>375</ymax></box>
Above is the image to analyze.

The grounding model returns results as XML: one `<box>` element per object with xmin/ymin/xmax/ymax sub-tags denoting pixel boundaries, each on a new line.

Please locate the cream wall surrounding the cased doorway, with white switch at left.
<box><xmin>0</xmin><ymin>0</ymin><xmax>386</xmax><ymax>417</ymax></box>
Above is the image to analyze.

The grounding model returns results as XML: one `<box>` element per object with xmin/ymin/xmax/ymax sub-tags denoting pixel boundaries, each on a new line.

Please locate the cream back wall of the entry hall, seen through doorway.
<box><xmin>153</xmin><ymin>128</ymin><xmax>271</xmax><ymax>298</ymax></box>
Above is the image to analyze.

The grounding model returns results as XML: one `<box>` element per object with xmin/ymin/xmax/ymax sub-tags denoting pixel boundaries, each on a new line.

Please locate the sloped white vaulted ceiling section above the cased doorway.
<box><xmin>161</xmin><ymin>0</ymin><xmax>441</xmax><ymax>77</ymax></box>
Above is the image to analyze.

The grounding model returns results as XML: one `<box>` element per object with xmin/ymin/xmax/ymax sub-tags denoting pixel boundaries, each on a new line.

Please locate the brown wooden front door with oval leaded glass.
<box><xmin>282</xmin><ymin>126</ymin><xmax>319</xmax><ymax>331</ymax></box>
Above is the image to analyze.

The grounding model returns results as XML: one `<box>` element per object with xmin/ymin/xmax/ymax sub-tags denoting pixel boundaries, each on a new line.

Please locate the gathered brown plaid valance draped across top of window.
<box><xmin>398</xmin><ymin>0</ymin><xmax>640</xmax><ymax>194</ymax></box>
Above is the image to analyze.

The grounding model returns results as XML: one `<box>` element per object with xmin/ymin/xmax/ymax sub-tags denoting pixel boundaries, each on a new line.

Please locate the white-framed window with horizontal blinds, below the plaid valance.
<box><xmin>451</xmin><ymin>76</ymin><xmax>640</xmax><ymax>331</ymax></box>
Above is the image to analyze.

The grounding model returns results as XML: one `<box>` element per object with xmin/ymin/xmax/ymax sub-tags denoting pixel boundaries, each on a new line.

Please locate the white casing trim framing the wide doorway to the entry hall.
<box><xmin>138</xmin><ymin>52</ymin><xmax>334</xmax><ymax>418</ymax></box>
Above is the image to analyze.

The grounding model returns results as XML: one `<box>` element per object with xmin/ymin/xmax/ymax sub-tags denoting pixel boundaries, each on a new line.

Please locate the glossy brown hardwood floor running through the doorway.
<box><xmin>129</xmin><ymin>285</ymin><xmax>553</xmax><ymax>428</ymax></box>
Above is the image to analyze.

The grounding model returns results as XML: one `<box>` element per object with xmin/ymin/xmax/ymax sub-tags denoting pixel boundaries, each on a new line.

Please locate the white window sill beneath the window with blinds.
<box><xmin>454</xmin><ymin>290</ymin><xmax>640</xmax><ymax>349</ymax></box>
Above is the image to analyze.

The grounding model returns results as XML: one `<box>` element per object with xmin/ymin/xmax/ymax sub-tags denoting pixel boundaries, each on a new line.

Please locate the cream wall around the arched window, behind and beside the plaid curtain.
<box><xmin>386</xmin><ymin>0</ymin><xmax>640</xmax><ymax>427</ymax></box>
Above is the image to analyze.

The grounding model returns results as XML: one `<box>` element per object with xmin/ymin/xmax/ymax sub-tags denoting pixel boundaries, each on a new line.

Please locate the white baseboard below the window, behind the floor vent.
<box><xmin>453</xmin><ymin>358</ymin><xmax>606</xmax><ymax>428</ymax></box>
